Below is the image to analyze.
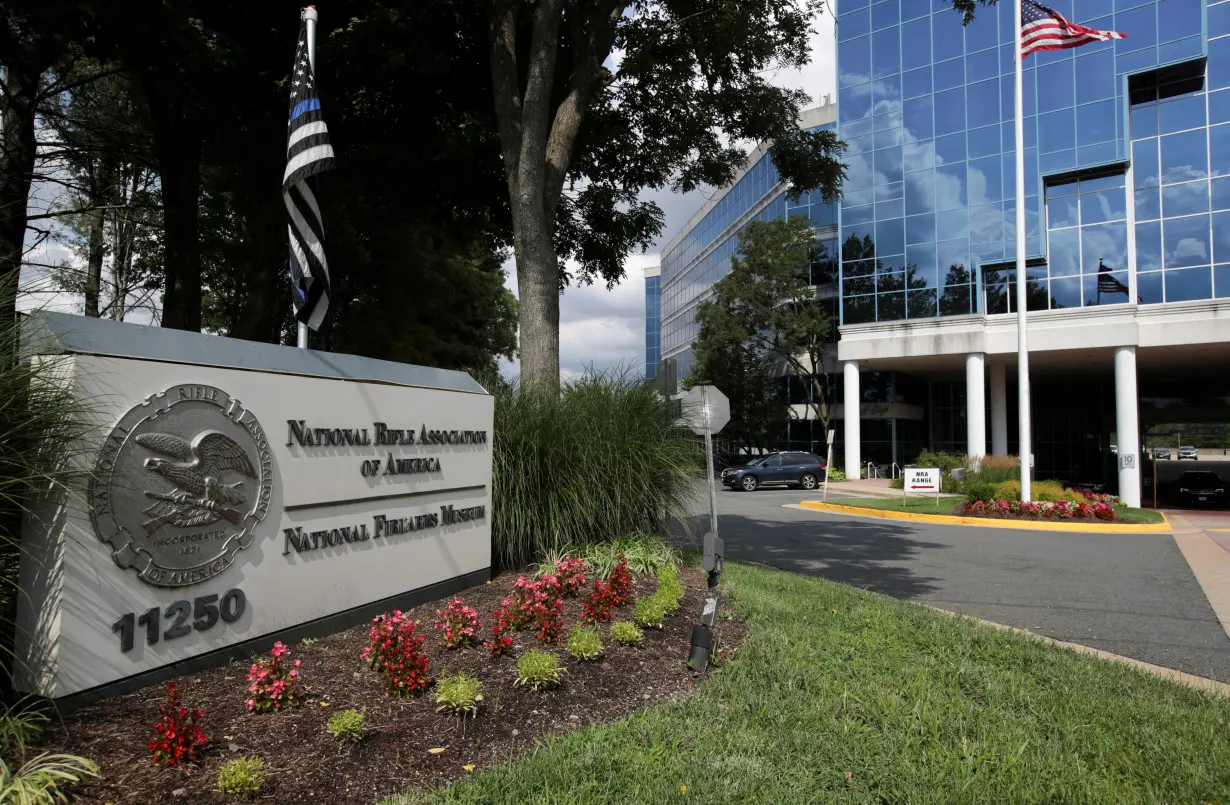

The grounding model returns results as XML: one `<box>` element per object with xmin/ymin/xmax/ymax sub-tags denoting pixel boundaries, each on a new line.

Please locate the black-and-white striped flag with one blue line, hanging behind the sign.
<box><xmin>282</xmin><ymin>10</ymin><xmax>333</xmax><ymax>330</ymax></box>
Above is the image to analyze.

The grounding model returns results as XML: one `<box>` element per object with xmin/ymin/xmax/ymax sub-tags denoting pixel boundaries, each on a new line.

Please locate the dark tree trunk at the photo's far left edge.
<box><xmin>0</xmin><ymin>57</ymin><xmax>43</xmax><ymax>321</ymax></box>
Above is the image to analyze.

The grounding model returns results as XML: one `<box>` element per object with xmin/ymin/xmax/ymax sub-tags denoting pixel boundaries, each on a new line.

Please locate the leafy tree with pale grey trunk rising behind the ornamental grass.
<box><xmin>490</xmin><ymin>0</ymin><xmax>844</xmax><ymax>385</ymax></box>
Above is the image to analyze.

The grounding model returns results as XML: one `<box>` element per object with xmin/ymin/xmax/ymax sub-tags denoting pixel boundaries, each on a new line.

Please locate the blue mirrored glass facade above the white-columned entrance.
<box><xmin>836</xmin><ymin>0</ymin><xmax>1230</xmax><ymax>324</ymax></box>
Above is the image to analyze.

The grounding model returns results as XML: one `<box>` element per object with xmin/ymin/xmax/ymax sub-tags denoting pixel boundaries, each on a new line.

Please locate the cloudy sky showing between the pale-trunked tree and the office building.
<box><xmin>503</xmin><ymin>9</ymin><xmax>836</xmax><ymax>379</ymax></box>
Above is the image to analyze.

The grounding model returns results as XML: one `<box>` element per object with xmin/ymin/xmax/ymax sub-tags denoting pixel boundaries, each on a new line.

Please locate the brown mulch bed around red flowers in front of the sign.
<box><xmin>41</xmin><ymin>569</ymin><xmax>745</xmax><ymax>805</ymax></box>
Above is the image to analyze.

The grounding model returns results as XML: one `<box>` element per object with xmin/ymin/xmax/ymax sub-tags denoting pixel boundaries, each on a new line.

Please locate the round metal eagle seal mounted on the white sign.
<box><xmin>90</xmin><ymin>383</ymin><xmax>273</xmax><ymax>587</ymax></box>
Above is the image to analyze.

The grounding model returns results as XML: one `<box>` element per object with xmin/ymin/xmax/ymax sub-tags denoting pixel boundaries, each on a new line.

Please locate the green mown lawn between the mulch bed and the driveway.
<box><xmin>387</xmin><ymin>563</ymin><xmax>1230</xmax><ymax>805</ymax></box>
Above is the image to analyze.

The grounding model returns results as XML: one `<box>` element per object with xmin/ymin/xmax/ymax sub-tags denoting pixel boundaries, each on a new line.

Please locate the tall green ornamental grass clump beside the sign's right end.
<box><xmin>487</xmin><ymin>373</ymin><xmax>704</xmax><ymax>567</ymax></box>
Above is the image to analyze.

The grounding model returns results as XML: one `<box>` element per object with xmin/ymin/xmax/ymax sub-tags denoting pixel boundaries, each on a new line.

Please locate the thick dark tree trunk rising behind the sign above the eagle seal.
<box><xmin>144</xmin><ymin>75</ymin><xmax>200</xmax><ymax>332</ymax></box>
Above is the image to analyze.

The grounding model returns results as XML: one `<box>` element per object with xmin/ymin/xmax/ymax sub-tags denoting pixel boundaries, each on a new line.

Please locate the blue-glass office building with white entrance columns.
<box><xmin>662</xmin><ymin>0</ymin><xmax>1230</xmax><ymax>504</ymax></box>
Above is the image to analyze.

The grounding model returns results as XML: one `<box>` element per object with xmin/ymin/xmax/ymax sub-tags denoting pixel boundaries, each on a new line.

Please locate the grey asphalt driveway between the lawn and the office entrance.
<box><xmin>674</xmin><ymin>490</ymin><xmax>1230</xmax><ymax>682</ymax></box>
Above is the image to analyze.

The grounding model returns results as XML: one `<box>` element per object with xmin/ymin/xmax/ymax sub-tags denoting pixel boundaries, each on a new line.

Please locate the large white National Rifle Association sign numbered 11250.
<box><xmin>17</xmin><ymin>330</ymin><xmax>493</xmax><ymax>698</ymax></box>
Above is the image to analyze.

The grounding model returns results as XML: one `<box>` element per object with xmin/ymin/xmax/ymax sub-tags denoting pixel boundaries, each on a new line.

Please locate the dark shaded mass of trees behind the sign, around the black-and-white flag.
<box><xmin>0</xmin><ymin>0</ymin><xmax>515</xmax><ymax>368</ymax></box>
